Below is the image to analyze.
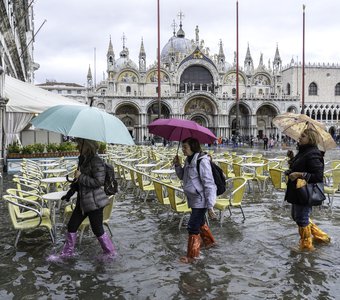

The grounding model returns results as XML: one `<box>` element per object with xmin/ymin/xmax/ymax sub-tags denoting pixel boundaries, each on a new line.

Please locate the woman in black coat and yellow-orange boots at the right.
<box><xmin>285</xmin><ymin>129</ymin><xmax>330</xmax><ymax>250</ymax></box>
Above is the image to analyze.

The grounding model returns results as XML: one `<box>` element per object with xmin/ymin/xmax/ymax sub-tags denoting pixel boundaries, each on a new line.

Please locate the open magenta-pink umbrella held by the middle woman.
<box><xmin>148</xmin><ymin>118</ymin><xmax>217</xmax><ymax>144</ymax></box>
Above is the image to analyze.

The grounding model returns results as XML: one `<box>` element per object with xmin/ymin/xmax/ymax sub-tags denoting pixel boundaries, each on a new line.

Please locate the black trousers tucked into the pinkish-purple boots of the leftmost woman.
<box><xmin>67</xmin><ymin>203</ymin><xmax>104</xmax><ymax>237</ymax></box>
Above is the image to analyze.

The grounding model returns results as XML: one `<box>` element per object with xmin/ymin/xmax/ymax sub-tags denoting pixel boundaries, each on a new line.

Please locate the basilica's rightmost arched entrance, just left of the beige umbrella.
<box><xmin>256</xmin><ymin>105</ymin><xmax>278</xmax><ymax>139</ymax></box>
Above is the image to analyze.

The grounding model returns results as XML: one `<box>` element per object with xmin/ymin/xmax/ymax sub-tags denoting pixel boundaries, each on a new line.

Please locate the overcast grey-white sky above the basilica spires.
<box><xmin>34</xmin><ymin>0</ymin><xmax>340</xmax><ymax>84</ymax></box>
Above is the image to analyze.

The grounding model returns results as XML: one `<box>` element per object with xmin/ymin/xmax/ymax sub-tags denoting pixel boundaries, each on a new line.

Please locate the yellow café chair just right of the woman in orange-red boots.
<box><xmin>214</xmin><ymin>177</ymin><xmax>247</xmax><ymax>226</ymax></box>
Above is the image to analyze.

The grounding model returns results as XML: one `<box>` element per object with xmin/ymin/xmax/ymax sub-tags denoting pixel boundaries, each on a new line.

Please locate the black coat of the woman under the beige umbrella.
<box><xmin>285</xmin><ymin>145</ymin><xmax>324</xmax><ymax>205</ymax></box>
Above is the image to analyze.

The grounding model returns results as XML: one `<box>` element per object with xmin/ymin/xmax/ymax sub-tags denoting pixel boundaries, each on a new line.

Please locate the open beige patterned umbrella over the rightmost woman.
<box><xmin>273</xmin><ymin>113</ymin><xmax>337</xmax><ymax>151</ymax></box>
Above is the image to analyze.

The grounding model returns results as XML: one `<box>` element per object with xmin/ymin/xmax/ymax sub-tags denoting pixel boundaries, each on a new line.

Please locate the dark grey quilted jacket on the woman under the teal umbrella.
<box><xmin>78</xmin><ymin>155</ymin><xmax>109</xmax><ymax>213</ymax></box>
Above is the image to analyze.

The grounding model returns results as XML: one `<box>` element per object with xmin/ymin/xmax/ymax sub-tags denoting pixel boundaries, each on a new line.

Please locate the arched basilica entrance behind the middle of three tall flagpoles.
<box><xmin>229</xmin><ymin>103</ymin><xmax>250</xmax><ymax>137</ymax></box>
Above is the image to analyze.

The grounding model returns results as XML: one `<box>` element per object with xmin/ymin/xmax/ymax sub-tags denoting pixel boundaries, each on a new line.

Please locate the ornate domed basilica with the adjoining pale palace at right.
<box><xmin>87</xmin><ymin>18</ymin><xmax>340</xmax><ymax>142</ymax></box>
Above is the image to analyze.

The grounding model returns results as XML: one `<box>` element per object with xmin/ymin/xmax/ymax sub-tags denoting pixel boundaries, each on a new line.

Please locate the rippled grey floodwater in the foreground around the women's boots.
<box><xmin>0</xmin><ymin>150</ymin><xmax>340</xmax><ymax>299</ymax></box>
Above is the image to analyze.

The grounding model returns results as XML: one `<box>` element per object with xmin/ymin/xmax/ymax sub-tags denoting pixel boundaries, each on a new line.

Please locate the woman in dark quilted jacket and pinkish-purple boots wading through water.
<box><xmin>49</xmin><ymin>138</ymin><xmax>116</xmax><ymax>261</ymax></box>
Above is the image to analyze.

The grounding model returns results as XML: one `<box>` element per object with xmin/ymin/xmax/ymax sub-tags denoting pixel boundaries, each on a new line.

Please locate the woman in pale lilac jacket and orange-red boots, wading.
<box><xmin>173</xmin><ymin>138</ymin><xmax>216</xmax><ymax>263</ymax></box>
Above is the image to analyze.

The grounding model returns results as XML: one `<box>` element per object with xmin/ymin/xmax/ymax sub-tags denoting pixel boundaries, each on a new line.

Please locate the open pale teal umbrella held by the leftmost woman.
<box><xmin>31</xmin><ymin>105</ymin><xmax>134</xmax><ymax>145</ymax></box>
